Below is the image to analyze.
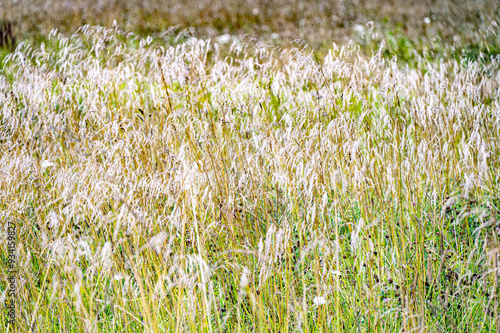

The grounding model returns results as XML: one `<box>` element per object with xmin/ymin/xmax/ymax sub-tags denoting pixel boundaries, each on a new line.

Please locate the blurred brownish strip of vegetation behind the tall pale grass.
<box><xmin>0</xmin><ymin>0</ymin><xmax>500</xmax><ymax>64</ymax></box>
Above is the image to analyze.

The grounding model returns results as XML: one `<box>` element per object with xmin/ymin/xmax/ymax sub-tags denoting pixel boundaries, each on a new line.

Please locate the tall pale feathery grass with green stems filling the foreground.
<box><xmin>0</xmin><ymin>1</ymin><xmax>500</xmax><ymax>332</ymax></box>
